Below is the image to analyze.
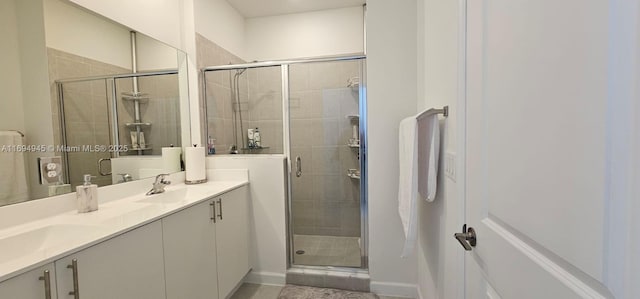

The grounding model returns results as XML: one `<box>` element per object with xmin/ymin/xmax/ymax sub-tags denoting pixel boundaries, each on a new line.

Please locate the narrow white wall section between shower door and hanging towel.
<box><xmin>367</xmin><ymin>0</ymin><xmax>417</xmax><ymax>297</ymax></box>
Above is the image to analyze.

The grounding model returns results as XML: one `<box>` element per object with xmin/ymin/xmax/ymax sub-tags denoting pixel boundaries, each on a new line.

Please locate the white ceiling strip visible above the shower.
<box><xmin>227</xmin><ymin>0</ymin><xmax>366</xmax><ymax>18</ymax></box>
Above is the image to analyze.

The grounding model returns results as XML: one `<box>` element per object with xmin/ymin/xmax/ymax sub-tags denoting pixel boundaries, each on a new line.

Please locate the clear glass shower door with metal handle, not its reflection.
<box><xmin>289</xmin><ymin>60</ymin><xmax>366</xmax><ymax>268</ymax></box>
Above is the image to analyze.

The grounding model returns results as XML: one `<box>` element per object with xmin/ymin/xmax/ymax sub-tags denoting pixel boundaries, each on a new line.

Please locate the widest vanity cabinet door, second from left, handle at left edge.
<box><xmin>55</xmin><ymin>221</ymin><xmax>165</xmax><ymax>299</ymax></box>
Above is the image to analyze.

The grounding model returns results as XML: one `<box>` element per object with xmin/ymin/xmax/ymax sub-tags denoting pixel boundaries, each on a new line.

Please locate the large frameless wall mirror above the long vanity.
<box><xmin>0</xmin><ymin>0</ymin><xmax>190</xmax><ymax>206</ymax></box>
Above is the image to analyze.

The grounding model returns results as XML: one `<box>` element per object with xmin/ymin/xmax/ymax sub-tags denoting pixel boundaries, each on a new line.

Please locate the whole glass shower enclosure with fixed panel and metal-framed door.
<box><xmin>202</xmin><ymin>56</ymin><xmax>368</xmax><ymax>269</ymax></box>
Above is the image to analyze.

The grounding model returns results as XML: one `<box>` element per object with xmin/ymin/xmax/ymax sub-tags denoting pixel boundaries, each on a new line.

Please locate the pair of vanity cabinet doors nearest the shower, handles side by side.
<box><xmin>162</xmin><ymin>187</ymin><xmax>249</xmax><ymax>299</ymax></box>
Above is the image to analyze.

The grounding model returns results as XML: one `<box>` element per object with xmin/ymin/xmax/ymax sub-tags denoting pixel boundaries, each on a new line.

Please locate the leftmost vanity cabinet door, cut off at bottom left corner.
<box><xmin>0</xmin><ymin>264</ymin><xmax>56</xmax><ymax>299</ymax></box>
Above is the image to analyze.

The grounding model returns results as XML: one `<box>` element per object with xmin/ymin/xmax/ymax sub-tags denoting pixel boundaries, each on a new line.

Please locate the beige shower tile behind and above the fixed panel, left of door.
<box><xmin>196</xmin><ymin>35</ymin><xmax>284</xmax><ymax>154</ymax></box>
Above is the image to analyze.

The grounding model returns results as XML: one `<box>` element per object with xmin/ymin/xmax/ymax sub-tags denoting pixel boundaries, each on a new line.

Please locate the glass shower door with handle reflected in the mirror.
<box><xmin>54</xmin><ymin>79</ymin><xmax>113</xmax><ymax>186</ymax></box>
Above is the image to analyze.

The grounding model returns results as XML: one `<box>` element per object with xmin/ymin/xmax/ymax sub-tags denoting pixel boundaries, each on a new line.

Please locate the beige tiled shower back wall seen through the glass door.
<box><xmin>289</xmin><ymin>61</ymin><xmax>360</xmax><ymax>237</ymax></box>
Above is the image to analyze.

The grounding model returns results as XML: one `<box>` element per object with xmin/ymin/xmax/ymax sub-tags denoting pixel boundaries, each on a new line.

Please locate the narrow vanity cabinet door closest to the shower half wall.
<box><xmin>216</xmin><ymin>187</ymin><xmax>249</xmax><ymax>298</ymax></box>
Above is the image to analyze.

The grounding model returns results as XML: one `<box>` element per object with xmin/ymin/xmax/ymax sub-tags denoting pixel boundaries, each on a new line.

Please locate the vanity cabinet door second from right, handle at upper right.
<box><xmin>162</xmin><ymin>200</ymin><xmax>218</xmax><ymax>299</ymax></box>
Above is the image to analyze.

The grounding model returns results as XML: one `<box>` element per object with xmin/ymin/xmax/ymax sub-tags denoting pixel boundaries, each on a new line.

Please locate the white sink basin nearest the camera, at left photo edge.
<box><xmin>0</xmin><ymin>224</ymin><xmax>101</xmax><ymax>264</ymax></box>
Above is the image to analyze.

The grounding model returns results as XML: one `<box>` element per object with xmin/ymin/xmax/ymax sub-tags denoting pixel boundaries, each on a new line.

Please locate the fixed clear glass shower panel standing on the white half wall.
<box><xmin>204</xmin><ymin>66</ymin><xmax>284</xmax><ymax>154</ymax></box>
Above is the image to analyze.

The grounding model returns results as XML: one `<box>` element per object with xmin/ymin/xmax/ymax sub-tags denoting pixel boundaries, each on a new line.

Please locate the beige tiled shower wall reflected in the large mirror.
<box><xmin>47</xmin><ymin>48</ymin><xmax>180</xmax><ymax>186</ymax></box>
